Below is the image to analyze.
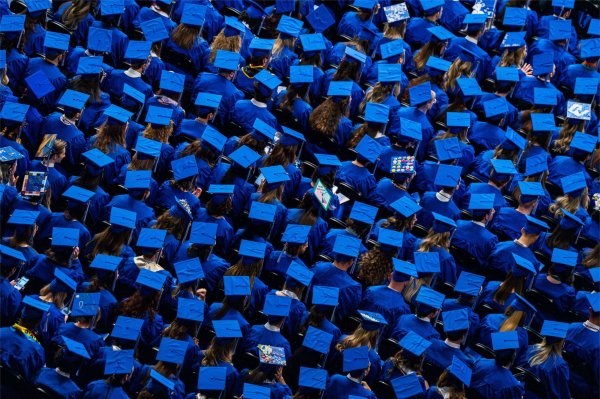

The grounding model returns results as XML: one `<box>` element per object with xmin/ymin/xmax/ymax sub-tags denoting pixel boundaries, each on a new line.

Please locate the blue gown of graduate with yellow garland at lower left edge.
<box><xmin>0</xmin><ymin>327</ymin><xmax>46</xmax><ymax>382</ymax></box>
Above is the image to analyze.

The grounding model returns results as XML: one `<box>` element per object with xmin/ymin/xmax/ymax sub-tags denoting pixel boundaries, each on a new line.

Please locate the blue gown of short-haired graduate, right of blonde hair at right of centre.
<box><xmin>452</xmin><ymin>220</ymin><xmax>498</xmax><ymax>266</ymax></box>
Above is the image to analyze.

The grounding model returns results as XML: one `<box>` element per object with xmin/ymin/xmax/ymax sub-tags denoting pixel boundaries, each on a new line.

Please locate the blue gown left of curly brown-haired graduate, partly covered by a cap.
<box><xmin>311</xmin><ymin>262</ymin><xmax>362</xmax><ymax>320</ymax></box>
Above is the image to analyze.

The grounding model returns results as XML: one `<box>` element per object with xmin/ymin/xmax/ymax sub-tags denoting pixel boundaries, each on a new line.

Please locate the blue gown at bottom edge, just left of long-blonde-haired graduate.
<box><xmin>471</xmin><ymin>358</ymin><xmax>524</xmax><ymax>399</ymax></box>
